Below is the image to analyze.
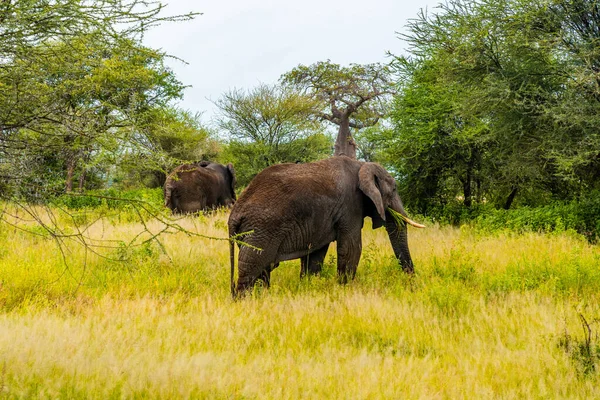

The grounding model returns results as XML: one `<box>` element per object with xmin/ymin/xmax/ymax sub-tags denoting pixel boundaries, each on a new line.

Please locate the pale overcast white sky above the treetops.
<box><xmin>144</xmin><ymin>0</ymin><xmax>440</xmax><ymax>121</ymax></box>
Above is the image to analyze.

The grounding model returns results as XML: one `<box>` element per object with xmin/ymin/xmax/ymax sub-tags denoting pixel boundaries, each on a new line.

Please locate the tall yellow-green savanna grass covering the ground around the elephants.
<box><xmin>0</xmin><ymin>208</ymin><xmax>600</xmax><ymax>399</ymax></box>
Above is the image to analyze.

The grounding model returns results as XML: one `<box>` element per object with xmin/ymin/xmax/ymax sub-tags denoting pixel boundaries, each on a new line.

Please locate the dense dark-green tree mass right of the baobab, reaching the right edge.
<box><xmin>381</xmin><ymin>0</ymin><xmax>600</xmax><ymax>214</ymax></box>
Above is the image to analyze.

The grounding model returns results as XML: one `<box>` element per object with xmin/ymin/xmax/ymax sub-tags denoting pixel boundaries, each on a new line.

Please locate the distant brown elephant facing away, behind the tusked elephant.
<box><xmin>164</xmin><ymin>161</ymin><xmax>236</xmax><ymax>214</ymax></box>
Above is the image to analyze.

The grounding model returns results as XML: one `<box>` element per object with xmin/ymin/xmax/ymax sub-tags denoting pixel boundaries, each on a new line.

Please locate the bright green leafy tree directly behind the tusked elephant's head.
<box><xmin>379</xmin><ymin>55</ymin><xmax>494</xmax><ymax>214</ymax></box>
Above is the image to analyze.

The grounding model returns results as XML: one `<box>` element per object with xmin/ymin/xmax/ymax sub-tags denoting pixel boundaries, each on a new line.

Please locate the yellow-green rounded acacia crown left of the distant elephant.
<box><xmin>4</xmin><ymin>36</ymin><xmax>183</xmax><ymax>194</ymax></box>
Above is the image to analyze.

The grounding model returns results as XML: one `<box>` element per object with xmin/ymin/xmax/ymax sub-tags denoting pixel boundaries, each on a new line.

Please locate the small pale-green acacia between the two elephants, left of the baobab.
<box><xmin>215</xmin><ymin>84</ymin><xmax>331</xmax><ymax>185</ymax></box>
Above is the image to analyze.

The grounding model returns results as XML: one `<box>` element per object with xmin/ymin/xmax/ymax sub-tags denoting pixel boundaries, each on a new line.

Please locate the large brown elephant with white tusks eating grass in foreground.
<box><xmin>229</xmin><ymin>156</ymin><xmax>423</xmax><ymax>297</ymax></box>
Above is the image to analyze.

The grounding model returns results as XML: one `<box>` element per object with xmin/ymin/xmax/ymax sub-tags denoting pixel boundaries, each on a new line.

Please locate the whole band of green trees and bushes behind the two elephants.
<box><xmin>0</xmin><ymin>0</ymin><xmax>600</xmax><ymax>240</ymax></box>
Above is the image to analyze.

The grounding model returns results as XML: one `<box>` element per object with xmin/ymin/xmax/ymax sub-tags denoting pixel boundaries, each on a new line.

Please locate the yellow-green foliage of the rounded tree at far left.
<box><xmin>4</xmin><ymin>38</ymin><xmax>188</xmax><ymax>198</ymax></box>
